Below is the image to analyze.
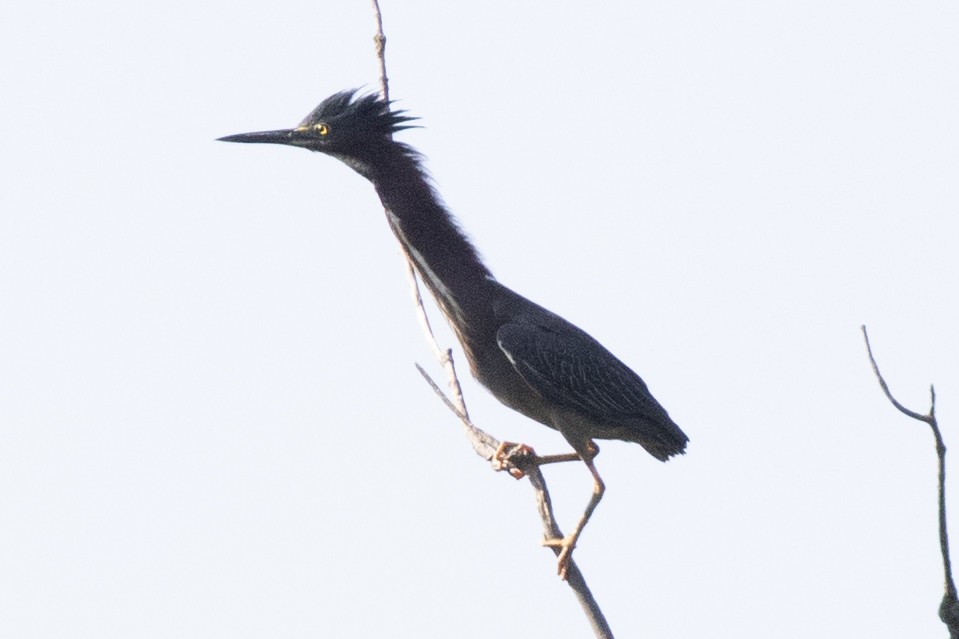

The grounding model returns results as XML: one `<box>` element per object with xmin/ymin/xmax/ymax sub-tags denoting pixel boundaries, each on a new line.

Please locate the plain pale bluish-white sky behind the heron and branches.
<box><xmin>0</xmin><ymin>0</ymin><xmax>959</xmax><ymax>639</ymax></box>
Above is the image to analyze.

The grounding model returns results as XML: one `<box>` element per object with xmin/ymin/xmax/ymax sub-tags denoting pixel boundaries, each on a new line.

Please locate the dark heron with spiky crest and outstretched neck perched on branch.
<box><xmin>219</xmin><ymin>89</ymin><xmax>689</xmax><ymax>579</ymax></box>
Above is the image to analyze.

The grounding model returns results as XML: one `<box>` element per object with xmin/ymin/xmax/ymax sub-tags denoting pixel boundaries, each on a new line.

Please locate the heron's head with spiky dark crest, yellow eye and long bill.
<box><xmin>220</xmin><ymin>89</ymin><xmax>415</xmax><ymax>164</ymax></box>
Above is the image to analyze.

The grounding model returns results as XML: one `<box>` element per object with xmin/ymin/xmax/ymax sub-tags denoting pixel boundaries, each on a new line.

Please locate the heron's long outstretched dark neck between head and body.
<box><xmin>361</xmin><ymin>143</ymin><xmax>495</xmax><ymax>338</ymax></box>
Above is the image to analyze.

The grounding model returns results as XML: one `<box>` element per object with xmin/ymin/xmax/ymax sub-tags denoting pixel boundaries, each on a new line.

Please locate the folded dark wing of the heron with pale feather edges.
<box><xmin>496</xmin><ymin>316</ymin><xmax>669</xmax><ymax>425</ymax></box>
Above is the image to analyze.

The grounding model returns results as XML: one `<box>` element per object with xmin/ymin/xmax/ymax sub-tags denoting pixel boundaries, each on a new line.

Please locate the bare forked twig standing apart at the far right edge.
<box><xmin>861</xmin><ymin>326</ymin><xmax>959</xmax><ymax>639</ymax></box>
